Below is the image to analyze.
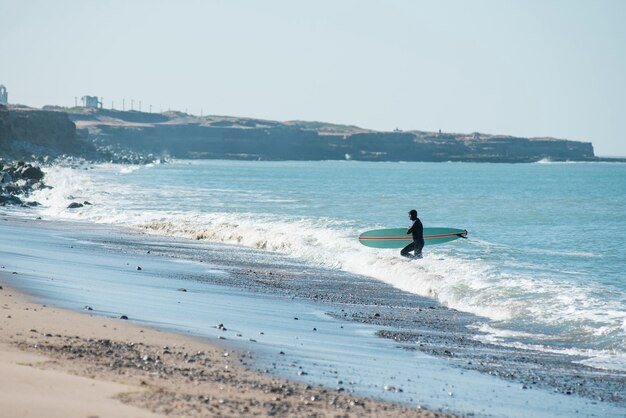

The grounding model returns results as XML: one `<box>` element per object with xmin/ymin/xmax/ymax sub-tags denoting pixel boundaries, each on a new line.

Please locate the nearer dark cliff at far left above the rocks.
<box><xmin>0</xmin><ymin>106</ymin><xmax>95</xmax><ymax>159</ymax></box>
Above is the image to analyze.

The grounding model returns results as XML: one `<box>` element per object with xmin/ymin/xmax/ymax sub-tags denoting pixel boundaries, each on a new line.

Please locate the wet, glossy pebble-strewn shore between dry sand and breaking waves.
<box><xmin>0</xmin><ymin>214</ymin><xmax>623</xmax><ymax>416</ymax></box>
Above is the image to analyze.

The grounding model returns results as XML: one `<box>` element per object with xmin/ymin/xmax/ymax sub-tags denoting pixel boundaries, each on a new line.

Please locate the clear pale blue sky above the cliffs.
<box><xmin>0</xmin><ymin>0</ymin><xmax>626</xmax><ymax>156</ymax></box>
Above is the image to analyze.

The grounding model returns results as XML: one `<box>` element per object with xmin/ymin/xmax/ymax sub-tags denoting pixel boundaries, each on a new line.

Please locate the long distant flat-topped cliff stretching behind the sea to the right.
<box><xmin>70</xmin><ymin>110</ymin><xmax>596</xmax><ymax>162</ymax></box>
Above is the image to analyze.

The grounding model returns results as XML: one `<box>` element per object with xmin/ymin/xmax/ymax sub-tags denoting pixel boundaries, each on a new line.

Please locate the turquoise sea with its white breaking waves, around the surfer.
<box><xmin>35</xmin><ymin>161</ymin><xmax>626</xmax><ymax>369</ymax></box>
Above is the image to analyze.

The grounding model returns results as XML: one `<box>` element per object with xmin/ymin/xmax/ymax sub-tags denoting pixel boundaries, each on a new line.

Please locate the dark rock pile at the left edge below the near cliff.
<box><xmin>0</xmin><ymin>160</ymin><xmax>49</xmax><ymax>207</ymax></box>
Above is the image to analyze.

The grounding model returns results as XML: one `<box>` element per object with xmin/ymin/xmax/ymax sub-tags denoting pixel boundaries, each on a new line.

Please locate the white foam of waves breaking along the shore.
<box><xmin>34</xmin><ymin>162</ymin><xmax>626</xmax><ymax>368</ymax></box>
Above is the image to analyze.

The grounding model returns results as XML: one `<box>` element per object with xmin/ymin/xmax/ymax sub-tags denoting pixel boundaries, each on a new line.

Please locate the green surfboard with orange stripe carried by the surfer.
<box><xmin>359</xmin><ymin>228</ymin><xmax>467</xmax><ymax>248</ymax></box>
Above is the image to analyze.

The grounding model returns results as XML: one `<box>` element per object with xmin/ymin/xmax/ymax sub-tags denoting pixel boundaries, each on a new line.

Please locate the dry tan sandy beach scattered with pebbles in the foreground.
<box><xmin>0</xmin><ymin>282</ymin><xmax>447</xmax><ymax>418</ymax></box>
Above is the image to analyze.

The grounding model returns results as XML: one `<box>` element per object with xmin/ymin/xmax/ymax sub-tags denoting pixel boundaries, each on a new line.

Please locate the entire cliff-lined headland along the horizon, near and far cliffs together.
<box><xmin>0</xmin><ymin>105</ymin><xmax>626</xmax><ymax>163</ymax></box>
